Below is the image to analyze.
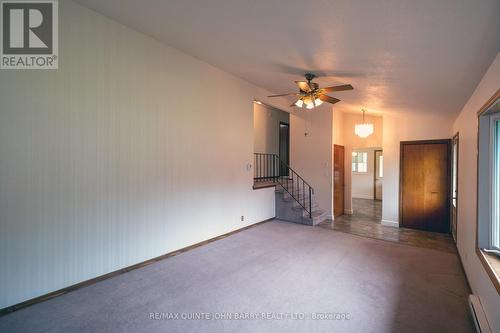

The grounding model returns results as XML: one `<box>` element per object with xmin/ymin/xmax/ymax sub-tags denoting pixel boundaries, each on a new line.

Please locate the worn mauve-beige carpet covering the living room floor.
<box><xmin>0</xmin><ymin>221</ymin><xmax>473</xmax><ymax>333</ymax></box>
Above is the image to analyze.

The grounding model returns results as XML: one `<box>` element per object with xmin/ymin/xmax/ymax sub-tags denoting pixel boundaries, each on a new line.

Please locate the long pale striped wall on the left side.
<box><xmin>0</xmin><ymin>0</ymin><xmax>290</xmax><ymax>308</ymax></box>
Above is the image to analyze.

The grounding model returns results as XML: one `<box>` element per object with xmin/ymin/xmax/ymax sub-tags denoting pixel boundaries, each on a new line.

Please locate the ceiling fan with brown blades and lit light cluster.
<box><xmin>268</xmin><ymin>73</ymin><xmax>354</xmax><ymax>109</ymax></box>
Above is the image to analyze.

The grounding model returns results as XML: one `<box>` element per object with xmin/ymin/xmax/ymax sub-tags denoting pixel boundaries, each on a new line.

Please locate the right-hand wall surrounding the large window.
<box><xmin>453</xmin><ymin>54</ymin><xmax>500</xmax><ymax>332</ymax></box>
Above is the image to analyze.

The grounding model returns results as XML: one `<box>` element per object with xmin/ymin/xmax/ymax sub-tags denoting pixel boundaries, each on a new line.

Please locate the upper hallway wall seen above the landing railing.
<box><xmin>253</xmin><ymin>103</ymin><xmax>290</xmax><ymax>155</ymax></box>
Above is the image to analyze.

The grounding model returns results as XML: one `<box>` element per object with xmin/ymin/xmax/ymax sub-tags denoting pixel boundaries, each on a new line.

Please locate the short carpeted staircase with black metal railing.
<box><xmin>254</xmin><ymin>153</ymin><xmax>327</xmax><ymax>225</ymax></box>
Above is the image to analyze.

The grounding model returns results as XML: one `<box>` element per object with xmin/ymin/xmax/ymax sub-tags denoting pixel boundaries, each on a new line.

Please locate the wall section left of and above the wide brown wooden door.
<box><xmin>382</xmin><ymin>114</ymin><xmax>452</xmax><ymax>226</ymax></box>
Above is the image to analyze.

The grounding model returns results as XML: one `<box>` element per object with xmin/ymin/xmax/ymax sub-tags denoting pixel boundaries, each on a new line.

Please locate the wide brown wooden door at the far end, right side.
<box><xmin>400</xmin><ymin>140</ymin><xmax>450</xmax><ymax>232</ymax></box>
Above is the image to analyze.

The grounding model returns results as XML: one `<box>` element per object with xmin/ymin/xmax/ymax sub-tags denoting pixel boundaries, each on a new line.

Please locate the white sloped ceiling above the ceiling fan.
<box><xmin>78</xmin><ymin>0</ymin><xmax>500</xmax><ymax>115</ymax></box>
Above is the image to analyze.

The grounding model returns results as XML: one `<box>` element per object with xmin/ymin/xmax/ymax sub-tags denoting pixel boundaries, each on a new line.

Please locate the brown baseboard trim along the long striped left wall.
<box><xmin>0</xmin><ymin>217</ymin><xmax>276</xmax><ymax>317</ymax></box>
